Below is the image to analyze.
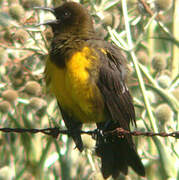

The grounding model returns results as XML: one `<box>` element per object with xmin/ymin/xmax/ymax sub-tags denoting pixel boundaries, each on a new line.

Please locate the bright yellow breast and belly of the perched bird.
<box><xmin>46</xmin><ymin>47</ymin><xmax>104</xmax><ymax>123</ymax></box>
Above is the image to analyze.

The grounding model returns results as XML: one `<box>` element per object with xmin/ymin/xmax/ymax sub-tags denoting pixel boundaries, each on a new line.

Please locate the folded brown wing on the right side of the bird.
<box><xmin>98</xmin><ymin>43</ymin><xmax>136</xmax><ymax>130</ymax></box>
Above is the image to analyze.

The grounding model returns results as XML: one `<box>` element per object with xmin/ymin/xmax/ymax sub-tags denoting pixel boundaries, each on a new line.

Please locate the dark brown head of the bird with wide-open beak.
<box><xmin>36</xmin><ymin>2</ymin><xmax>93</xmax><ymax>34</ymax></box>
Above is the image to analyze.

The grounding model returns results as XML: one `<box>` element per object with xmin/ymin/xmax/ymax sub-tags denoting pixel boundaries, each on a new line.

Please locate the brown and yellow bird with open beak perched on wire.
<box><xmin>36</xmin><ymin>1</ymin><xmax>145</xmax><ymax>179</ymax></box>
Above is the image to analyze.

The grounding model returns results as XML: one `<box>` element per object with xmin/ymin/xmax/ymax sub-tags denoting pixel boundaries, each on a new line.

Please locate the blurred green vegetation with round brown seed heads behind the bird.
<box><xmin>0</xmin><ymin>0</ymin><xmax>179</xmax><ymax>180</ymax></box>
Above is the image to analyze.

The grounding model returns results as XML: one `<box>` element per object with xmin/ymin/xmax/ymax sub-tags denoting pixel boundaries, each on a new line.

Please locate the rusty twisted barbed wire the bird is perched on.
<box><xmin>0</xmin><ymin>127</ymin><xmax>179</xmax><ymax>139</ymax></box>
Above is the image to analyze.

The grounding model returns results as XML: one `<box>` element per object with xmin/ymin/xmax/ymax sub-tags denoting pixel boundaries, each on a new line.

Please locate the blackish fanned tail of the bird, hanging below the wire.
<box><xmin>96</xmin><ymin>131</ymin><xmax>145</xmax><ymax>179</ymax></box>
